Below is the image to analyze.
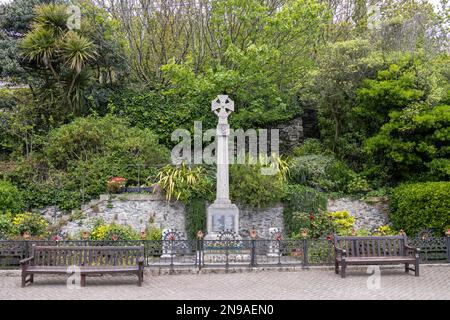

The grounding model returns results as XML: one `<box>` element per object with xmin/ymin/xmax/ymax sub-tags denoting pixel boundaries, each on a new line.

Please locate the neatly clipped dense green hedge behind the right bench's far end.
<box><xmin>390</xmin><ymin>182</ymin><xmax>450</xmax><ymax>236</ymax></box>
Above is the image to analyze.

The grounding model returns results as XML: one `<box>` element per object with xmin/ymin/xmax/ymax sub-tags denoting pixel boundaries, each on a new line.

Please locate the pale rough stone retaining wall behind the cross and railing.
<box><xmin>42</xmin><ymin>194</ymin><xmax>388</xmax><ymax>239</ymax></box>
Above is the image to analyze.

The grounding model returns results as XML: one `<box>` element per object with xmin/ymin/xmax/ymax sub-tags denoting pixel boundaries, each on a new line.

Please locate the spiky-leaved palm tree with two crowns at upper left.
<box><xmin>21</xmin><ymin>4</ymin><xmax>97</xmax><ymax>115</ymax></box>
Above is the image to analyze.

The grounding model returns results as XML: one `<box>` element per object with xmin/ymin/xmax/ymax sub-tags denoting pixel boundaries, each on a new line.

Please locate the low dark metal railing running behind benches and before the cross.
<box><xmin>0</xmin><ymin>237</ymin><xmax>450</xmax><ymax>271</ymax></box>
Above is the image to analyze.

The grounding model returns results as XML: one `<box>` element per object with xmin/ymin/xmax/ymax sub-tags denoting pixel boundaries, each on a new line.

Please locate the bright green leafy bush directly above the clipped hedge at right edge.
<box><xmin>366</xmin><ymin>104</ymin><xmax>450</xmax><ymax>181</ymax></box>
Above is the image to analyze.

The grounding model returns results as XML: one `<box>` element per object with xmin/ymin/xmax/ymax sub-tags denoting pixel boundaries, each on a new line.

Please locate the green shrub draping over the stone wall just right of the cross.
<box><xmin>283</xmin><ymin>185</ymin><xmax>327</xmax><ymax>236</ymax></box>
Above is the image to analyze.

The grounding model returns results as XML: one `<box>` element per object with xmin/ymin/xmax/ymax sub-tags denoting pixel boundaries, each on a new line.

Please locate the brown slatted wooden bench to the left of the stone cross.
<box><xmin>20</xmin><ymin>245</ymin><xmax>144</xmax><ymax>287</ymax></box>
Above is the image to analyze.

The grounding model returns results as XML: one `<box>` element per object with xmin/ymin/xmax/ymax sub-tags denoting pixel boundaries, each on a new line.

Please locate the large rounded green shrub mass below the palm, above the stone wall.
<box><xmin>6</xmin><ymin>116</ymin><xmax>169</xmax><ymax>212</ymax></box>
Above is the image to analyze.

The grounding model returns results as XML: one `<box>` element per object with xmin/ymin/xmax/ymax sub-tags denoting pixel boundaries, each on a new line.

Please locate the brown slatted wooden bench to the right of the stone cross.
<box><xmin>334</xmin><ymin>235</ymin><xmax>420</xmax><ymax>278</ymax></box>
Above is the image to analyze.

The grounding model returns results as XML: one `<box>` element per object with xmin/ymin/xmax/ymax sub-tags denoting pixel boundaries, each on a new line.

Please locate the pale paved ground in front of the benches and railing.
<box><xmin>0</xmin><ymin>265</ymin><xmax>450</xmax><ymax>300</ymax></box>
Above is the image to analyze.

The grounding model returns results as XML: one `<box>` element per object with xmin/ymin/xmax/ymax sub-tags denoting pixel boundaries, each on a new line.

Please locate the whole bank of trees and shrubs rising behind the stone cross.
<box><xmin>0</xmin><ymin>0</ymin><xmax>450</xmax><ymax>236</ymax></box>
